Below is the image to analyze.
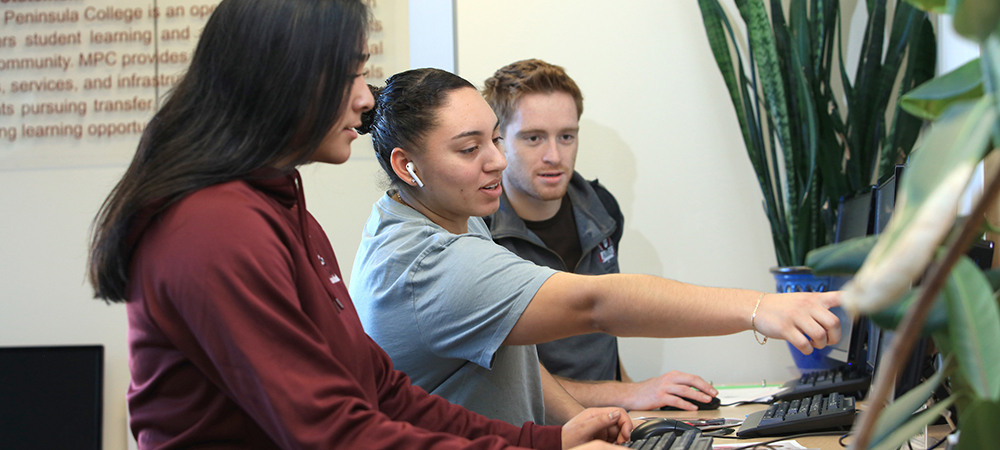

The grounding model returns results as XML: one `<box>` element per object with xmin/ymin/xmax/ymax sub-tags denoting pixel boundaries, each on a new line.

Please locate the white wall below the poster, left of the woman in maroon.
<box><xmin>0</xmin><ymin>167</ymin><xmax>128</xmax><ymax>449</ymax></box>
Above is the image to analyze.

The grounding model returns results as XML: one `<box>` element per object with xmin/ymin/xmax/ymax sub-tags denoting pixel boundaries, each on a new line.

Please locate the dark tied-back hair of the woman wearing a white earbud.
<box><xmin>358</xmin><ymin>69</ymin><xmax>476</xmax><ymax>187</ymax></box>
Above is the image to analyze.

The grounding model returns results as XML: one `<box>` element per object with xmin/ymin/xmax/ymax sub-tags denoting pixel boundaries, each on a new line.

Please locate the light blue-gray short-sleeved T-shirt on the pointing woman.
<box><xmin>350</xmin><ymin>195</ymin><xmax>556</xmax><ymax>425</ymax></box>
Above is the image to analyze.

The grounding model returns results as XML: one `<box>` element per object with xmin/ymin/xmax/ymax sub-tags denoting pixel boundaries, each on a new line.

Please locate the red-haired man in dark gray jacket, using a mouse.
<box><xmin>483</xmin><ymin>60</ymin><xmax>716</xmax><ymax>410</ymax></box>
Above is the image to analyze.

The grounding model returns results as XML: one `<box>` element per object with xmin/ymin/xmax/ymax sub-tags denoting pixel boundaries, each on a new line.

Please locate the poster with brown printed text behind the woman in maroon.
<box><xmin>0</xmin><ymin>0</ymin><xmax>409</xmax><ymax>170</ymax></box>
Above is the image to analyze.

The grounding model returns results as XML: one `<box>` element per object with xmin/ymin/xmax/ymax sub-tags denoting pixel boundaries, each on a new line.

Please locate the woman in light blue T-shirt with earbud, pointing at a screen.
<box><xmin>351</xmin><ymin>69</ymin><xmax>840</xmax><ymax>423</ymax></box>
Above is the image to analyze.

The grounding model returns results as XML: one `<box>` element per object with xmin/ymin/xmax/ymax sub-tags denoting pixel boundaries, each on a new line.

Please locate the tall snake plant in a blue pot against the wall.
<box><xmin>698</xmin><ymin>0</ymin><xmax>937</xmax><ymax>369</ymax></box>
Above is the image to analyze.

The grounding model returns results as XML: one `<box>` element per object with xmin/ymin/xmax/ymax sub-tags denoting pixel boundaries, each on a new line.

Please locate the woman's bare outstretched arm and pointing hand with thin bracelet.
<box><xmin>504</xmin><ymin>272</ymin><xmax>840</xmax><ymax>354</ymax></box>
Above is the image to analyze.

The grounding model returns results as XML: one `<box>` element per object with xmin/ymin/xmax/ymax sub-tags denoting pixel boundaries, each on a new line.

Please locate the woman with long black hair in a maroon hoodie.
<box><xmin>90</xmin><ymin>0</ymin><xmax>631</xmax><ymax>449</ymax></box>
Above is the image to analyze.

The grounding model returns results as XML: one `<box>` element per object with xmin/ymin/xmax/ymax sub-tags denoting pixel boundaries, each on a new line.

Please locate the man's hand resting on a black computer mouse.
<box><xmin>622</xmin><ymin>370</ymin><xmax>719</xmax><ymax>411</ymax></box>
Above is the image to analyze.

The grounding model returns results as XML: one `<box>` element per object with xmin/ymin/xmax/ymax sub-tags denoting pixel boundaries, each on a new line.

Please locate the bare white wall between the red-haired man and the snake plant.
<box><xmin>456</xmin><ymin>0</ymin><xmax>793</xmax><ymax>383</ymax></box>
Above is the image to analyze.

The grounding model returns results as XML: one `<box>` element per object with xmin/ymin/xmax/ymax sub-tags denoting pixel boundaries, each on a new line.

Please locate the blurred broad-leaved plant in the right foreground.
<box><xmin>808</xmin><ymin>0</ymin><xmax>1000</xmax><ymax>449</ymax></box>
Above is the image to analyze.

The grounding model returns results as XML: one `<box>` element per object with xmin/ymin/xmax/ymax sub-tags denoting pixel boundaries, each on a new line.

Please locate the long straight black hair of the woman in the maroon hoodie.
<box><xmin>89</xmin><ymin>0</ymin><xmax>370</xmax><ymax>301</ymax></box>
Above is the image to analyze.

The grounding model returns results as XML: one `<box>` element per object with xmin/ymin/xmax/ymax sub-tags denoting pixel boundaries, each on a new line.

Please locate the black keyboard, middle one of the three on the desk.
<box><xmin>736</xmin><ymin>393</ymin><xmax>854</xmax><ymax>437</ymax></box>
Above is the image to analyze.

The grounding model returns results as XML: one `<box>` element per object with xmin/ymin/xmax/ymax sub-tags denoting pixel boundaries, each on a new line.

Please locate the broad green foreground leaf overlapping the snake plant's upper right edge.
<box><xmin>899</xmin><ymin>58</ymin><xmax>983</xmax><ymax>120</ymax></box>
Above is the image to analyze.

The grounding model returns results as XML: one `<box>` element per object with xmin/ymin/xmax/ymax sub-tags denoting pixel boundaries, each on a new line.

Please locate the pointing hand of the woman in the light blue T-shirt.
<box><xmin>753</xmin><ymin>292</ymin><xmax>840</xmax><ymax>355</ymax></box>
